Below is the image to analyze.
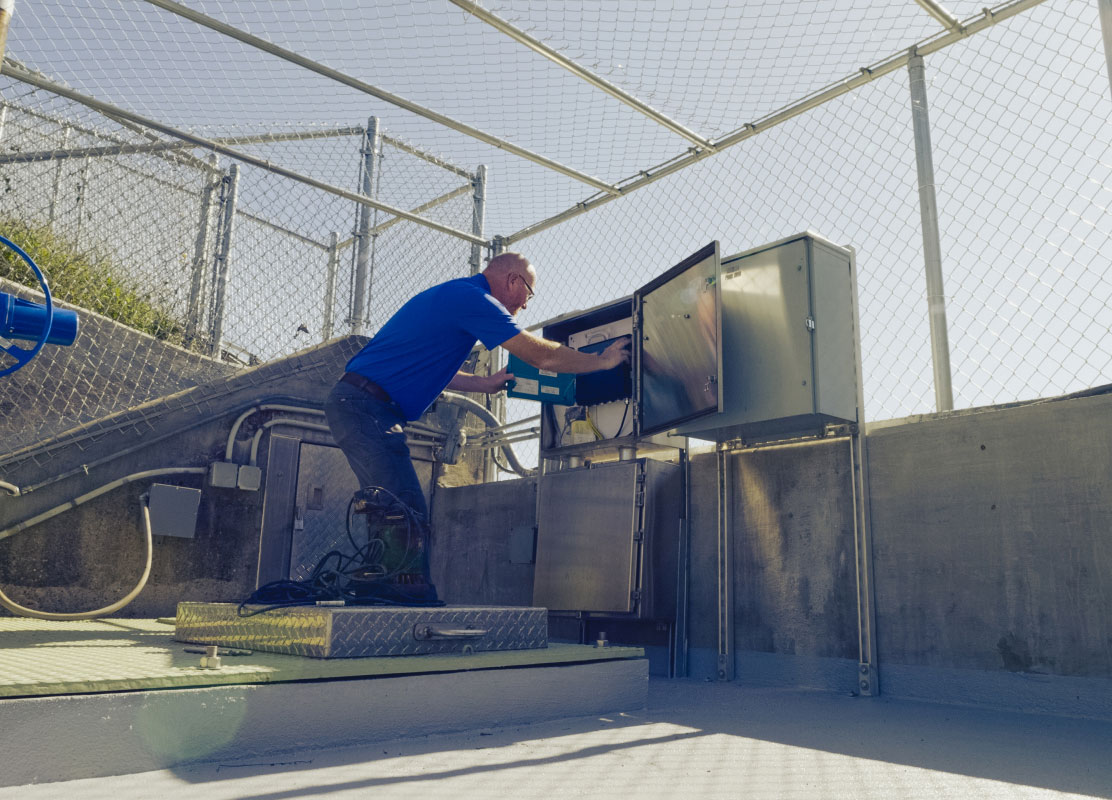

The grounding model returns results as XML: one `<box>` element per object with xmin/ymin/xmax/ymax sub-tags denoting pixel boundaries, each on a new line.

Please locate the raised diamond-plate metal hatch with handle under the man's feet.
<box><xmin>173</xmin><ymin>603</ymin><xmax>548</xmax><ymax>659</ymax></box>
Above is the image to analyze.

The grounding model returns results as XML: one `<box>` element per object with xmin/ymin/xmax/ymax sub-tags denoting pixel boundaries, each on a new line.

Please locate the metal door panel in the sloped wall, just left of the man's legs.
<box><xmin>289</xmin><ymin>443</ymin><xmax>359</xmax><ymax>581</ymax></box>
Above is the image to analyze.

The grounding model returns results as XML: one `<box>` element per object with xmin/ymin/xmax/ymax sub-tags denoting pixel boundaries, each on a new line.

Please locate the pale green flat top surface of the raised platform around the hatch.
<box><xmin>0</xmin><ymin>618</ymin><xmax>644</xmax><ymax>698</ymax></box>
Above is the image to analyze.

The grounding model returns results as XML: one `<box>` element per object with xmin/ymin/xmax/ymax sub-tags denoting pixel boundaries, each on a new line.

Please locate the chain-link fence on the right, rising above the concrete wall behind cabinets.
<box><xmin>514</xmin><ymin>0</ymin><xmax>1112</xmax><ymax>419</ymax></box>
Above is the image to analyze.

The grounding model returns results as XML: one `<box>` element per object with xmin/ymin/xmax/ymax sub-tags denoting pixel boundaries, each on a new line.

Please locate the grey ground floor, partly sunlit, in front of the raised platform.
<box><xmin>0</xmin><ymin>679</ymin><xmax>1112</xmax><ymax>800</ymax></box>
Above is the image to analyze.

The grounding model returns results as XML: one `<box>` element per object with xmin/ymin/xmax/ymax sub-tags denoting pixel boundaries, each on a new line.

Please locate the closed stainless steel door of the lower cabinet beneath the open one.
<box><xmin>533</xmin><ymin>461</ymin><xmax>642</xmax><ymax>613</ymax></box>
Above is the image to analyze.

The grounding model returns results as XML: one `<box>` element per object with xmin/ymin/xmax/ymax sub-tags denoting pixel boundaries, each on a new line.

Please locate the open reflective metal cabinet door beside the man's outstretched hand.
<box><xmin>634</xmin><ymin>241</ymin><xmax>722</xmax><ymax>435</ymax></box>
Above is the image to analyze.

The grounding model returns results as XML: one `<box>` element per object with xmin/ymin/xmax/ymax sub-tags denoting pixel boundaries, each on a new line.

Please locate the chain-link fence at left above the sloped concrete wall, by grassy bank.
<box><xmin>0</xmin><ymin>79</ymin><xmax>477</xmax><ymax>453</ymax></box>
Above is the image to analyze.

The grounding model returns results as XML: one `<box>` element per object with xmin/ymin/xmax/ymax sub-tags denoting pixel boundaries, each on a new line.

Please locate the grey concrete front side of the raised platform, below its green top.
<box><xmin>0</xmin><ymin>659</ymin><xmax>648</xmax><ymax>787</ymax></box>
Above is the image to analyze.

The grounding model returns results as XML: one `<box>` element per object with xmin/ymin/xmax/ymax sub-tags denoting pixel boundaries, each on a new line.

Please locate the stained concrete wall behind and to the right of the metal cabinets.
<box><xmin>437</xmin><ymin>396</ymin><xmax>1112</xmax><ymax>717</ymax></box>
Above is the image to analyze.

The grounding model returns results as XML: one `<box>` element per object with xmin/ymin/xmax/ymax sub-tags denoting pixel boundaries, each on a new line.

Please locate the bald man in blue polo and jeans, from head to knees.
<box><xmin>325</xmin><ymin>253</ymin><xmax>629</xmax><ymax>524</ymax></box>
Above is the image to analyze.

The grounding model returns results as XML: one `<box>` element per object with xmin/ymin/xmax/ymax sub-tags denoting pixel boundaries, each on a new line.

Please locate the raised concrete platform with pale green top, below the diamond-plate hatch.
<box><xmin>0</xmin><ymin>619</ymin><xmax>648</xmax><ymax>787</ymax></box>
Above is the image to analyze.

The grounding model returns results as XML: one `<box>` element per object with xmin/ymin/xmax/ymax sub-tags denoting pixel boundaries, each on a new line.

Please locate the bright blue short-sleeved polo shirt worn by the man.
<box><xmin>347</xmin><ymin>275</ymin><xmax>522</xmax><ymax>419</ymax></box>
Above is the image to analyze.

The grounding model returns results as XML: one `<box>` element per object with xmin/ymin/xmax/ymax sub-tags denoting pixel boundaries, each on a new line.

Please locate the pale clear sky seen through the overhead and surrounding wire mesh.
<box><xmin>4</xmin><ymin>0</ymin><xmax>1112</xmax><ymax>445</ymax></box>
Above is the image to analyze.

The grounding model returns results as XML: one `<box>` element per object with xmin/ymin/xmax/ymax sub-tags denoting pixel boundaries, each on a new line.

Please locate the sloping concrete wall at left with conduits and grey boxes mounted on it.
<box><xmin>0</xmin><ymin>337</ymin><xmax>363</xmax><ymax>616</ymax></box>
